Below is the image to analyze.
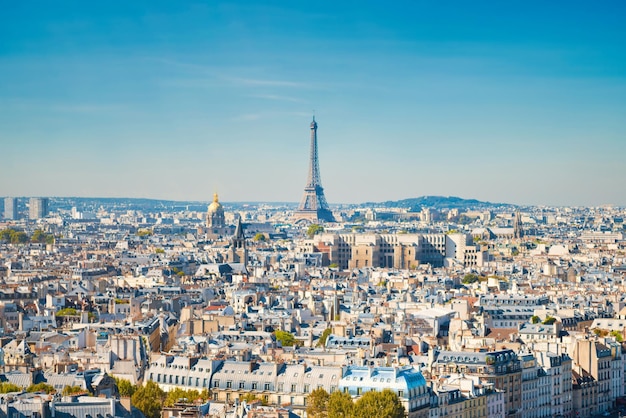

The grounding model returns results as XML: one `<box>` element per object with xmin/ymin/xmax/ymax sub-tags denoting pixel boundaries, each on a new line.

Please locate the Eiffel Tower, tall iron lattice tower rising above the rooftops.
<box><xmin>294</xmin><ymin>116</ymin><xmax>335</xmax><ymax>222</ymax></box>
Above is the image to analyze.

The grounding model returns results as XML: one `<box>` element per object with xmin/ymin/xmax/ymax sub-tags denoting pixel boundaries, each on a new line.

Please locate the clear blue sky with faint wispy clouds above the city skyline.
<box><xmin>0</xmin><ymin>1</ymin><xmax>626</xmax><ymax>206</ymax></box>
